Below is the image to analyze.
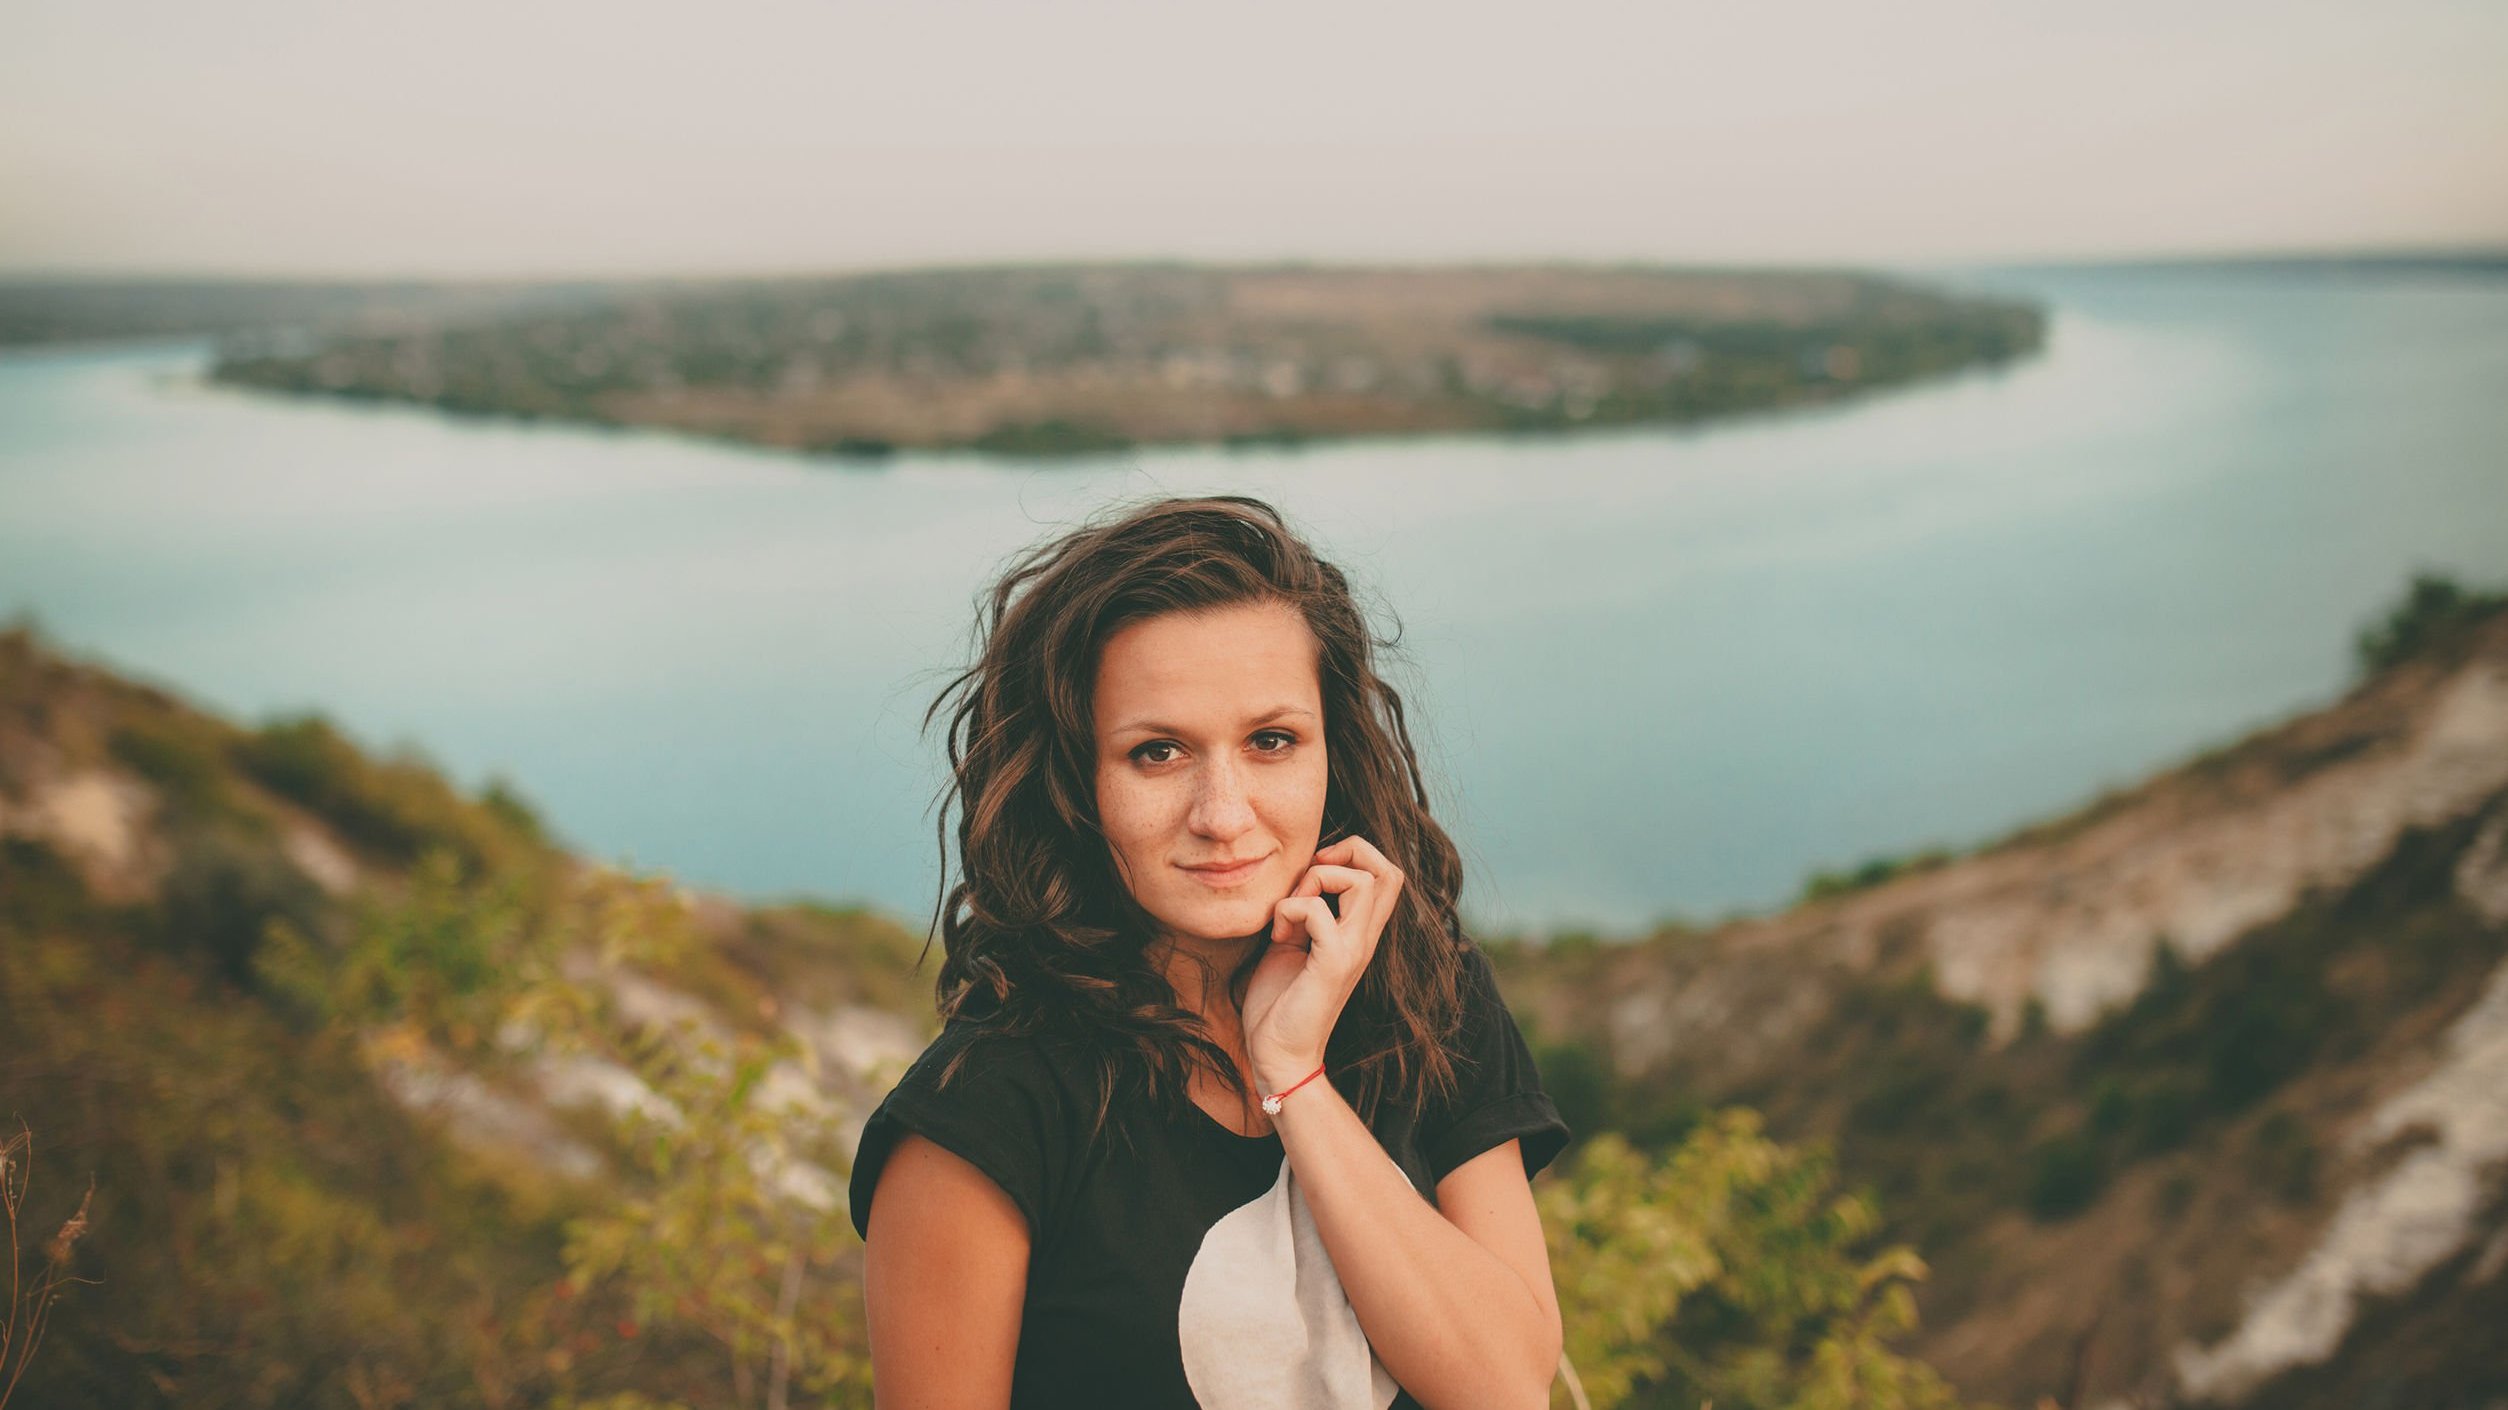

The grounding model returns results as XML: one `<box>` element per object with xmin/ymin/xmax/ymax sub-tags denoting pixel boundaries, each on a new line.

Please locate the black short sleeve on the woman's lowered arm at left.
<box><xmin>845</xmin><ymin>1024</ymin><xmax>1066</xmax><ymax>1244</ymax></box>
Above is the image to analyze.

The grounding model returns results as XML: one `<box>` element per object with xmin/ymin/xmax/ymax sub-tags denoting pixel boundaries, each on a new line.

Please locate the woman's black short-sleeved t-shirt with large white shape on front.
<box><xmin>850</xmin><ymin>943</ymin><xmax>1568</xmax><ymax>1410</ymax></box>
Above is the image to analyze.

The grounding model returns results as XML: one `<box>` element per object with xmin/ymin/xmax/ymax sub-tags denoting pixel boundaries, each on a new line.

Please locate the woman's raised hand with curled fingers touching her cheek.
<box><xmin>1244</xmin><ymin>838</ymin><xmax>1402</xmax><ymax>1091</ymax></box>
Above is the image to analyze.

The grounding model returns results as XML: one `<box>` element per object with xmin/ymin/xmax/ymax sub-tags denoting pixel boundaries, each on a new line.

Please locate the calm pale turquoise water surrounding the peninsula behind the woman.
<box><xmin>0</xmin><ymin>271</ymin><xmax>2508</xmax><ymax>928</ymax></box>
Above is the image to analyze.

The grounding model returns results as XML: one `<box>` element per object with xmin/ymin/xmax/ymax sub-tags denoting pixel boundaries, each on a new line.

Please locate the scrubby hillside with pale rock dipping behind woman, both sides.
<box><xmin>0</xmin><ymin>564</ymin><xmax>2508</xmax><ymax>1410</ymax></box>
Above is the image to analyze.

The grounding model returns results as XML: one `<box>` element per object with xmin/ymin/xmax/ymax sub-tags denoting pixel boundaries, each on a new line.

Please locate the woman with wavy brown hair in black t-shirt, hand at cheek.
<box><xmin>853</xmin><ymin>497</ymin><xmax>1568</xmax><ymax>1410</ymax></box>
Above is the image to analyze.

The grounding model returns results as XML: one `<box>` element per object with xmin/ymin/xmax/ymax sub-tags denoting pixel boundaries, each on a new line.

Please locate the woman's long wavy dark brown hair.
<box><xmin>923</xmin><ymin>494</ymin><xmax>1462</xmax><ymax>1139</ymax></box>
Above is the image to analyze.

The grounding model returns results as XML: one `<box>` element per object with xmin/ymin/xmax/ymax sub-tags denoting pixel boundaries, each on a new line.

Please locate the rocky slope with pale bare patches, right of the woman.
<box><xmin>1505</xmin><ymin>615</ymin><xmax>2508</xmax><ymax>1405</ymax></box>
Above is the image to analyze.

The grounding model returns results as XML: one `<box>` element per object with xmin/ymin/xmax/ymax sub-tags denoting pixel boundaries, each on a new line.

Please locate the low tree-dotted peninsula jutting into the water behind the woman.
<box><xmin>213</xmin><ymin>263</ymin><xmax>2044</xmax><ymax>457</ymax></box>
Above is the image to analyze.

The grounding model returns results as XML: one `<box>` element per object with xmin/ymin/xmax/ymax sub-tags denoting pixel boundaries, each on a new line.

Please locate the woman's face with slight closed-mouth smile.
<box><xmin>1093</xmin><ymin>602</ymin><xmax>1329</xmax><ymax>941</ymax></box>
